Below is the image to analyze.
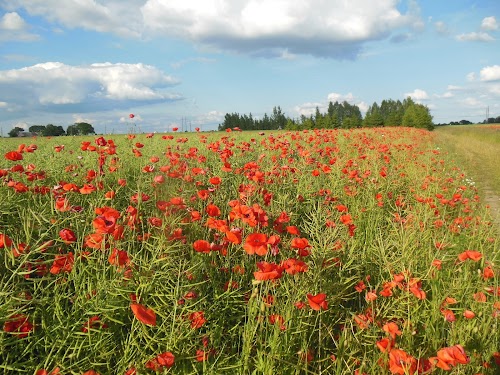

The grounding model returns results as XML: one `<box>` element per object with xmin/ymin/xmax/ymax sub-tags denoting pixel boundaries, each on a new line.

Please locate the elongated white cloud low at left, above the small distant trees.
<box><xmin>0</xmin><ymin>62</ymin><xmax>182</xmax><ymax>112</ymax></box>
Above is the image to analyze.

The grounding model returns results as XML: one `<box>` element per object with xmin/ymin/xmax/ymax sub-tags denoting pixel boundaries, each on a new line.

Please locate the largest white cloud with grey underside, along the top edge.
<box><xmin>6</xmin><ymin>0</ymin><xmax>423</xmax><ymax>59</ymax></box>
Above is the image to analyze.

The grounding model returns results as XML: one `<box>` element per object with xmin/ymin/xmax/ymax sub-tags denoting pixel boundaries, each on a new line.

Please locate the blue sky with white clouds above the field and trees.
<box><xmin>0</xmin><ymin>0</ymin><xmax>500</xmax><ymax>136</ymax></box>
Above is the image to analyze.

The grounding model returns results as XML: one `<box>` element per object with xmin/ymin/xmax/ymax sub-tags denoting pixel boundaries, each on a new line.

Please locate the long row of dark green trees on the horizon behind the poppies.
<box><xmin>219</xmin><ymin>97</ymin><xmax>434</xmax><ymax>130</ymax></box>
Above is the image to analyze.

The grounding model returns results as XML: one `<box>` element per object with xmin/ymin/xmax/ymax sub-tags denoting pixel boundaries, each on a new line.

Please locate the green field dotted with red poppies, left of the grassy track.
<box><xmin>0</xmin><ymin>128</ymin><xmax>500</xmax><ymax>375</ymax></box>
